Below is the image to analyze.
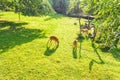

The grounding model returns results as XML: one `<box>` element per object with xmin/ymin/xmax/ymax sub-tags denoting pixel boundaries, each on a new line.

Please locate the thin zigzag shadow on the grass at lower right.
<box><xmin>89</xmin><ymin>43</ymin><xmax>104</xmax><ymax>71</ymax></box>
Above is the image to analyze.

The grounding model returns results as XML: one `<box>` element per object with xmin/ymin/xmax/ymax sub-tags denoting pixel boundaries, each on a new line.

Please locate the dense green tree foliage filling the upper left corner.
<box><xmin>0</xmin><ymin>0</ymin><xmax>55</xmax><ymax>16</ymax></box>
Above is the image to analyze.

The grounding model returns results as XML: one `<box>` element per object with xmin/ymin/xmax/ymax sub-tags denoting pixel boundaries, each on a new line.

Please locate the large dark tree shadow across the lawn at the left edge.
<box><xmin>0</xmin><ymin>21</ymin><xmax>45</xmax><ymax>53</ymax></box>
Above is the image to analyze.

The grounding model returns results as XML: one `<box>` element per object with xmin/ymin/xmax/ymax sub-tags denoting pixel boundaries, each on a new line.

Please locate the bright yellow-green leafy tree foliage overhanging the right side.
<box><xmin>82</xmin><ymin>0</ymin><xmax>120</xmax><ymax>47</ymax></box>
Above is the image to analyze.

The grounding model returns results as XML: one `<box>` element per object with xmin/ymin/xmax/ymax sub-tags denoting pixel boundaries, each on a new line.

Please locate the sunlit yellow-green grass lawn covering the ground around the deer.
<box><xmin>0</xmin><ymin>12</ymin><xmax>120</xmax><ymax>80</ymax></box>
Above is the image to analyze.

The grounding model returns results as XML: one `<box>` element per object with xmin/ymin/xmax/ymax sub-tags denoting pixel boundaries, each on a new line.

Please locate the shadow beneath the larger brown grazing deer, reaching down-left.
<box><xmin>44</xmin><ymin>42</ymin><xmax>59</xmax><ymax>56</ymax></box>
